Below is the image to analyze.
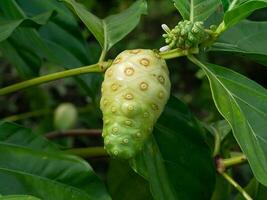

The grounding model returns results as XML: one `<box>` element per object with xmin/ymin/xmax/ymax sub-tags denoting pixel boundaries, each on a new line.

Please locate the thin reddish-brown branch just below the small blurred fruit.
<box><xmin>45</xmin><ymin>129</ymin><xmax>102</xmax><ymax>139</ymax></box>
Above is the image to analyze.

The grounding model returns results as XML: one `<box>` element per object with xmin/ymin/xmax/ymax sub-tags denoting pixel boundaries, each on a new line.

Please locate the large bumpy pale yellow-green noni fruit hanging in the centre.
<box><xmin>100</xmin><ymin>49</ymin><xmax>171</xmax><ymax>159</ymax></box>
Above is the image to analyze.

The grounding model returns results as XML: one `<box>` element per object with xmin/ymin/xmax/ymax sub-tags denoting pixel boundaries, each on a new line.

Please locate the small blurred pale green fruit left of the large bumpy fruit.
<box><xmin>54</xmin><ymin>103</ymin><xmax>78</xmax><ymax>130</ymax></box>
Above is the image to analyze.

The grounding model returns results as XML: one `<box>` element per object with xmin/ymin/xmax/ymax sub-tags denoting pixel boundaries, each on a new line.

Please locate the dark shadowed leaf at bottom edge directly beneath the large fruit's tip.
<box><xmin>107</xmin><ymin>160</ymin><xmax>153</xmax><ymax>200</ymax></box>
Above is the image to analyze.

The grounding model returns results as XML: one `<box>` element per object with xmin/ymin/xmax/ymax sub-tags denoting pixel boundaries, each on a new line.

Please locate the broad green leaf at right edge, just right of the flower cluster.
<box><xmin>210</xmin><ymin>20</ymin><xmax>267</xmax><ymax>65</ymax></box>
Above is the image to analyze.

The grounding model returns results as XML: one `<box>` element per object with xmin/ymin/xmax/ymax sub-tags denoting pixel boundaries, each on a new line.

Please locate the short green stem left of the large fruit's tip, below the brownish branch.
<box><xmin>65</xmin><ymin>147</ymin><xmax>108</xmax><ymax>158</ymax></box>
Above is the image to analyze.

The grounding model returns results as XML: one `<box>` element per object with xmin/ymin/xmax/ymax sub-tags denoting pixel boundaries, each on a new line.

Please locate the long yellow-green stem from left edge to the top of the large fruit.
<box><xmin>0</xmin><ymin>63</ymin><xmax>109</xmax><ymax>96</ymax></box>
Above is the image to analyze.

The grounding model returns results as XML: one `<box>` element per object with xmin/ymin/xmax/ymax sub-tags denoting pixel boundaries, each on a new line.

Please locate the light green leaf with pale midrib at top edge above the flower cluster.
<box><xmin>172</xmin><ymin>0</ymin><xmax>220</xmax><ymax>22</ymax></box>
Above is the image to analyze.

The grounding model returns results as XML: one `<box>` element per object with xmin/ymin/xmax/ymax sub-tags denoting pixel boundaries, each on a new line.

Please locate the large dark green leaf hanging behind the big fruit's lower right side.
<box><xmin>131</xmin><ymin>97</ymin><xmax>215</xmax><ymax>200</ymax></box>
